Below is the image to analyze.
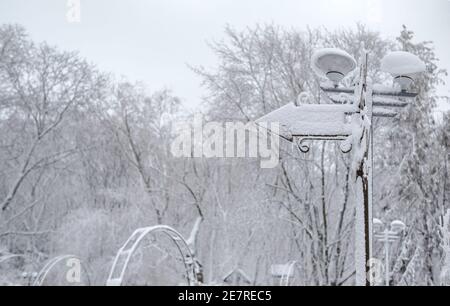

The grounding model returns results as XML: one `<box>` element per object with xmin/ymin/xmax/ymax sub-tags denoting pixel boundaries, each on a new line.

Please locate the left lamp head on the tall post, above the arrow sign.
<box><xmin>311</xmin><ymin>48</ymin><xmax>356</xmax><ymax>84</ymax></box>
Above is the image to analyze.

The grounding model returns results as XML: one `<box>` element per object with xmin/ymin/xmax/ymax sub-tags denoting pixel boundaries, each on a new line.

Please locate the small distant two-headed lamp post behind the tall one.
<box><xmin>373</xmin><ymin>219</ymin><xmax>406</xmax><ymax>286</ymax></box>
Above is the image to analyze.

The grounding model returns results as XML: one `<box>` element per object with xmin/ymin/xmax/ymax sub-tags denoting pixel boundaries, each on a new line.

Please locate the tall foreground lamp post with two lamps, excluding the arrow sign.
<box><xmin>312</xmin><ymin>49</ymin><xmax>425</xmax><ymax>286</ymax></box>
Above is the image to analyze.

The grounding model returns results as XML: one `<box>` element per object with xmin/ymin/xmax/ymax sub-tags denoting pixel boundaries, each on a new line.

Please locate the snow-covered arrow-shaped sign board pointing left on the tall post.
<box><xmin>256</xmin><ymin>103</ymin><xmax>357</xmax><ymax>141</ymax></box>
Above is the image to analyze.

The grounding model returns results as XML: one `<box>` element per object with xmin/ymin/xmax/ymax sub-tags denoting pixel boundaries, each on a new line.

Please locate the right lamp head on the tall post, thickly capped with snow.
<box><xmin>381</xmin><ymin>51</ymin><xmax>426</xmax><ymax>90</ymax></box>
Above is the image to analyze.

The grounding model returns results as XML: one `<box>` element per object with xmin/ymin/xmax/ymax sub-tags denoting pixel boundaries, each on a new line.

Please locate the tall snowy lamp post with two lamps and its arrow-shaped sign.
<box><xmin>256</xmin><ymin>49</ymin><xmax>425</xmax><ymax>286</ymax></box>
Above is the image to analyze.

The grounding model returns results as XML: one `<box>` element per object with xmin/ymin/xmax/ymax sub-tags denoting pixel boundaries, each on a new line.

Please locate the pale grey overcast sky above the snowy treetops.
<box><xmin>0</xmin><ymin>0</ymin><xmax>450</xmax><ymax>109</ymax></box>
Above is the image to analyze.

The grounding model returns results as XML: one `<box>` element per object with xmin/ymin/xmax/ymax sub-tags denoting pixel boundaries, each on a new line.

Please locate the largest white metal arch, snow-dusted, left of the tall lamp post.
<box><xmin>106</xmin><ymin>225</ymin><xmax>197</xmax><ymax>286</ymax></box>
